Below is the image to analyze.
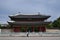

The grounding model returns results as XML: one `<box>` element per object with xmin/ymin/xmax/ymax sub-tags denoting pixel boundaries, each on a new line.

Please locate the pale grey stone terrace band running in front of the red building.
<box><xmin>0</xmin><ymin>32</ymin><xmax>60</xmax><ymax>37</ymax></box>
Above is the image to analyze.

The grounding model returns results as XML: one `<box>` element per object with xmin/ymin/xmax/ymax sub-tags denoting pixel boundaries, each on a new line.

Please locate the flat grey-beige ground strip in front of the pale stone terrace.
<box><xmin>0</xmin><ymin>37</ymin><xmax>60</xmax><ymax>40</ymax></box>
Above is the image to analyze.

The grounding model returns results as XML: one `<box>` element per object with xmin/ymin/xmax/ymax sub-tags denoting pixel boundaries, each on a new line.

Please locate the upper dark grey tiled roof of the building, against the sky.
<box><xmin>9</xmin><ymin>15</ymin><xmax>50</xmax><ymax>18</ymax></box>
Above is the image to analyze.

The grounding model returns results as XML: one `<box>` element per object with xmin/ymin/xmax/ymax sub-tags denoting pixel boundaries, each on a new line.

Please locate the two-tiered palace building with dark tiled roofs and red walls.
<box><xmin>8</xmin><ymin>14</ymin><xmax>50</xmax><ymax>32</ymax></box>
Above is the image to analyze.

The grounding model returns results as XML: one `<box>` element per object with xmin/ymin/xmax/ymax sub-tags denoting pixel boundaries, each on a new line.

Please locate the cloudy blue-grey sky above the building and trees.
<box><xmin>0</xmin><ymin>0</ymin><xmax>60</xmax><ymax>23</ymax></box>
